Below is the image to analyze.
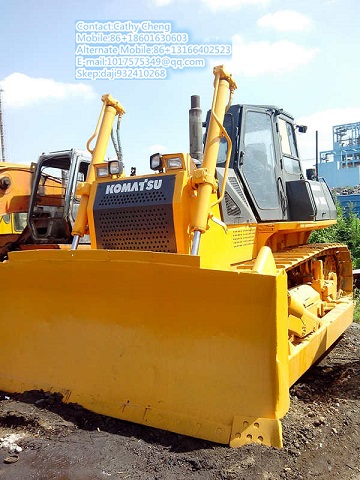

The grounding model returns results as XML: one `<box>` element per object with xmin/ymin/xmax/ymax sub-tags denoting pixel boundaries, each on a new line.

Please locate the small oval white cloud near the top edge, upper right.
<box><xmin>256</xmin><ymin>10</ymin><xmax>311</xmax><ymax>32</ymax></box>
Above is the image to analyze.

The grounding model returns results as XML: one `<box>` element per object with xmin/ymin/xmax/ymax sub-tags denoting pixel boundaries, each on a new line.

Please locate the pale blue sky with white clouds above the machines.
<box><xmin>0</xmin><ymin>0</ymin><xmax>360</xmax><ymax>173</ymax></box>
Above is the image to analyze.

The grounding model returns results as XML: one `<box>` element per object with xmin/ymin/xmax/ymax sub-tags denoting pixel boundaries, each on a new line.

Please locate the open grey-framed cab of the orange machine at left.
<box><xmin>27</xmin><ymin>149</ymin><xmax>90</xmax><ymax>243</ymax></box>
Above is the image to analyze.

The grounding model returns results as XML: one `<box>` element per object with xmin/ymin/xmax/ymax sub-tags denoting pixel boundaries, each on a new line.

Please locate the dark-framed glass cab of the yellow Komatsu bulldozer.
<box><xmin>211</xmin><ymin>105</ymin><xmax>336</xmax><ymax>223</ymax></box>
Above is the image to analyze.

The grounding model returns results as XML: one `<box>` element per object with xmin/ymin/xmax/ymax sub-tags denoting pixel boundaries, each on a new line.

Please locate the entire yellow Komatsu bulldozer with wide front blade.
<box><xmin>0</xmin><ymin>66</ymin><xmax>353</xmax><ymax>447</ymax></box>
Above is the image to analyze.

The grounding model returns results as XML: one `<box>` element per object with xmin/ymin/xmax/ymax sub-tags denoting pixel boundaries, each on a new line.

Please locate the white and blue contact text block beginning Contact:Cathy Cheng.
<box><xmin>75</xmin><ymin>20</ymin><xmax>232</xmax><ymax>80</ymax></box>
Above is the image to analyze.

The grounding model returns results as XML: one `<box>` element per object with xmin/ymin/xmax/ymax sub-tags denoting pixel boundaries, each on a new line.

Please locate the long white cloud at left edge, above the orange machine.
<box><xmin>0</xmin><ymin>72</ymin><xmax>96</xmax><ymax>108</ymax></box>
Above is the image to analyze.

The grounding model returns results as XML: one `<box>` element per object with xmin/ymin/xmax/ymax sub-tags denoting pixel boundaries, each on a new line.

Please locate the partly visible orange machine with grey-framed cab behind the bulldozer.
<box><xmin>0</xmin><ymin>149</ymin><xmax>90</xmax><ymax>259</ymax></box>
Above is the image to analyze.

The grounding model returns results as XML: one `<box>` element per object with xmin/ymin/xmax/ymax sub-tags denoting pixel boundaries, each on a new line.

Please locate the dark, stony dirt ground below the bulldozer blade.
<box><xmin>0</xmin><ymin>324</ymin><xmax>360</xmax><ymax>480</ymax></box>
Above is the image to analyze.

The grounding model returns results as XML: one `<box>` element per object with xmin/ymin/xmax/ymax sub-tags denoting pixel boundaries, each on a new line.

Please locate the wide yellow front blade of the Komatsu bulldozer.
<box><xmin>0</xmin><ymin>250</ymin><xmax>348</xmax><ymax>447</ymax></box>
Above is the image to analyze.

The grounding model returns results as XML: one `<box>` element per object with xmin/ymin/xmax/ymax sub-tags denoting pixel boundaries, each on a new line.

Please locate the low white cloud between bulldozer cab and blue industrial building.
<box><xmin>296</xmin><ymin>106</ymin><xmax>360</xmax><ymax>163</ymax></box>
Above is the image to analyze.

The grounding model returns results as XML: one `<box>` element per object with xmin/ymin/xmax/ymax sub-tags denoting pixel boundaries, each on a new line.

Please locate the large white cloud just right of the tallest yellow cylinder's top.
<box><xmin>226</xmin><ymin>35</ymin><xmax>319</xmax><ymax>77</ymax></box>
